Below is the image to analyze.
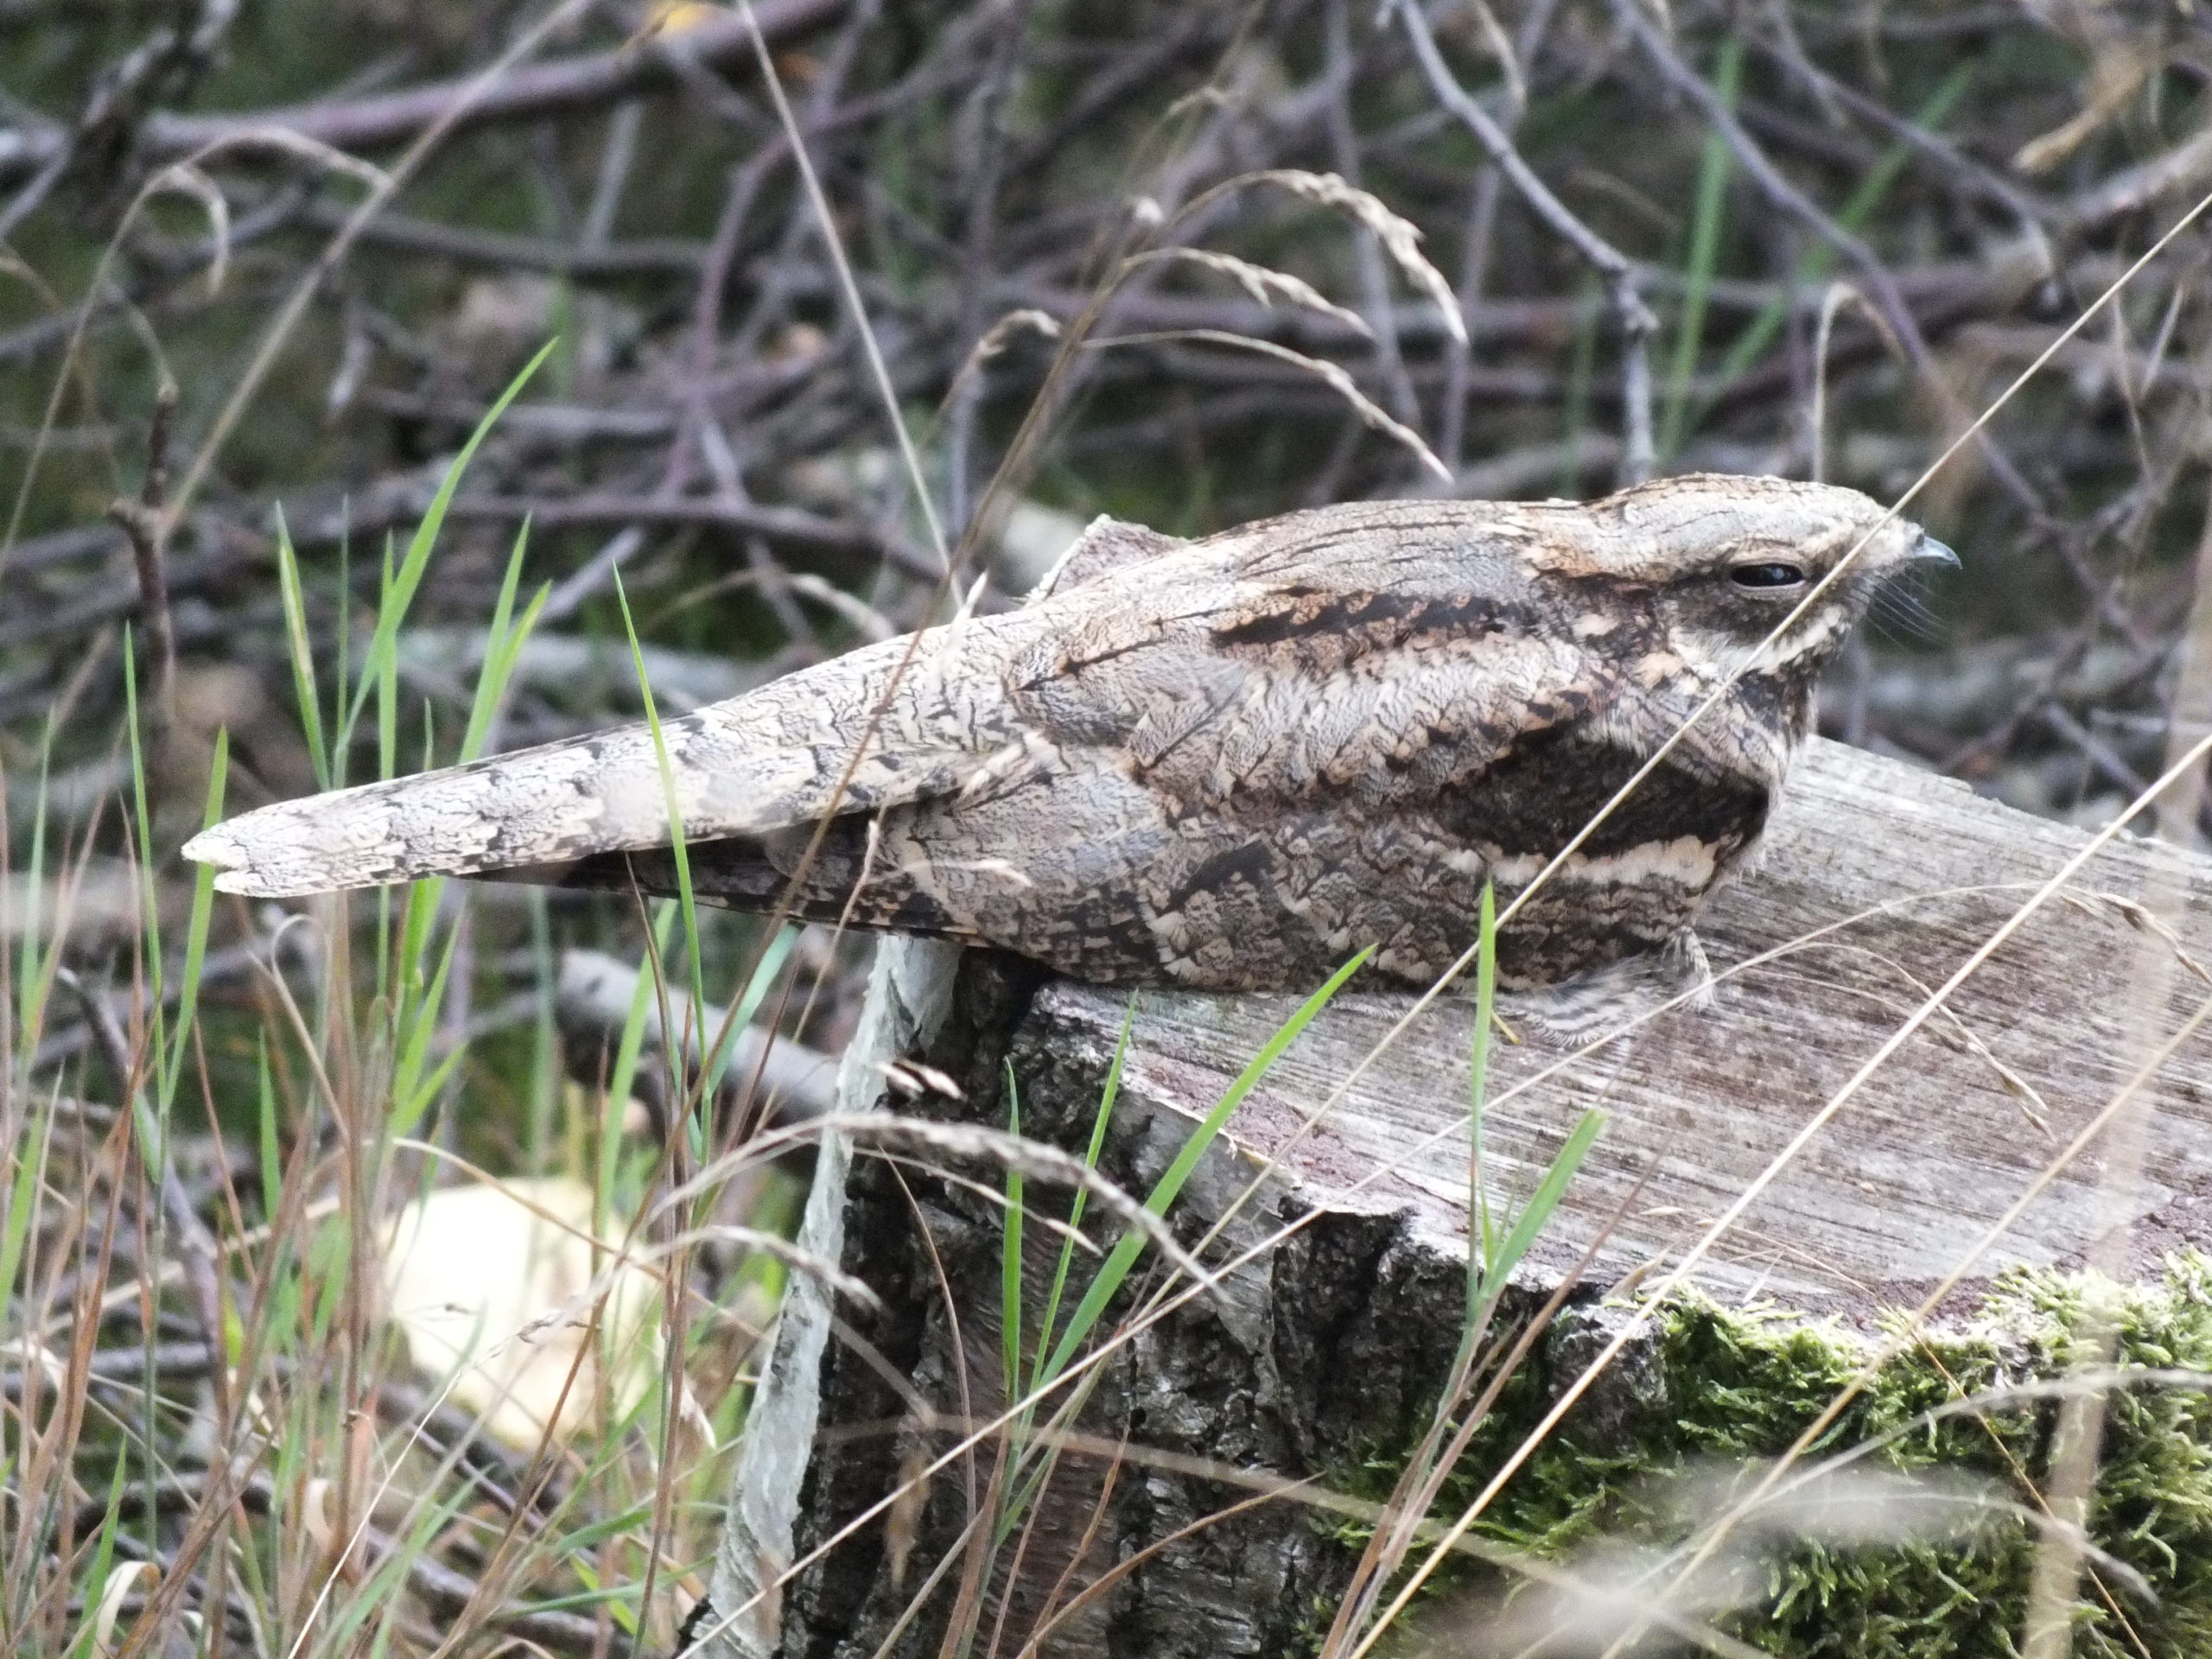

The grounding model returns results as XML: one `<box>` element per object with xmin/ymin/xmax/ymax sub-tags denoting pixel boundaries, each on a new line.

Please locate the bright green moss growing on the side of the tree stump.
<box><xmin>1347</xmin><ymin>1252</ymin><xmax>2212</xmax><ymax>1659</ymax></box>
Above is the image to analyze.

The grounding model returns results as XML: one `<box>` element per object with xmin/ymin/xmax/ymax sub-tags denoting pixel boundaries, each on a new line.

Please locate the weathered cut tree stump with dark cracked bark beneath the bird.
<box><xmin>695</xmin><ymin>743</ymin><xmax>2212</xmax><ymax>1659</ymax></box>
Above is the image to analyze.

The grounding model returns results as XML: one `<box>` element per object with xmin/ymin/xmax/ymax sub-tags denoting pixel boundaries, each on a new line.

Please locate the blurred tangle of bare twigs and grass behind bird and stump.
<box><xmin>0</xmin><ymin>0</ymin><xmax>2212</xmax><ymax>1652</ymax></box>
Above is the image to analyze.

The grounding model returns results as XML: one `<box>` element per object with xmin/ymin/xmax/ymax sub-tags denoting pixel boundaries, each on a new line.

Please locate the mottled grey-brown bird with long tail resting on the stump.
<box><xmin>186</xmin><ymin>475</ymin><xmax>1948</xmax><ymax>991</ymax></box>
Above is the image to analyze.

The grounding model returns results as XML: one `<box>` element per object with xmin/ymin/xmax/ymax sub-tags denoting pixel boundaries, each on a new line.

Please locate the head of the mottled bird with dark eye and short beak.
<box><xmin>1588</xmin><ymin>474</ymin><xmax>1958</xmax><ymax>688</ymax></box>
